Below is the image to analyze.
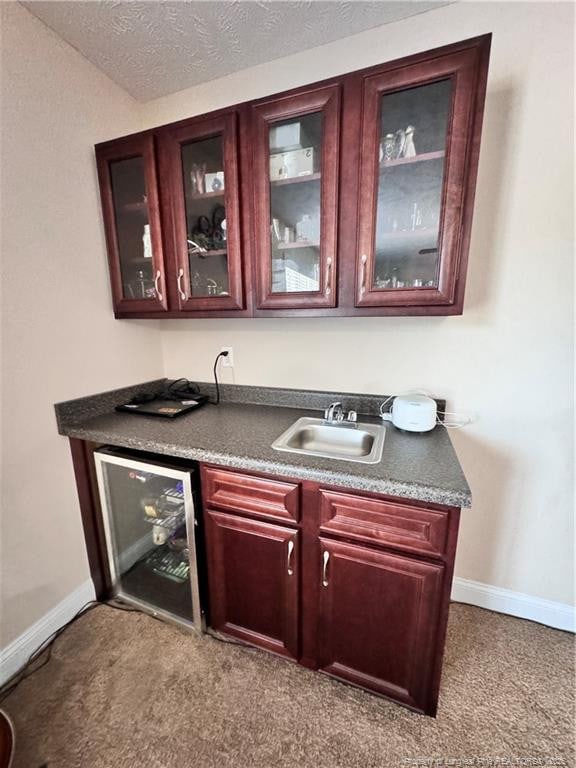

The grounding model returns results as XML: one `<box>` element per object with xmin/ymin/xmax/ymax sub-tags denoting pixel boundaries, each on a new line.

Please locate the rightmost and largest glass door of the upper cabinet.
<box><xmin>356</xmin><ymin>45</ymin><xmax>484</xmax><ymax>306</ymax></box>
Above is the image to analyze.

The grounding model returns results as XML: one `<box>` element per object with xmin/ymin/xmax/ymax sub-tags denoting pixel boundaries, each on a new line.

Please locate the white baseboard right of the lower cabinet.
<box><xmin>452</xmin><ymin>578</ymin><xmax>576</xmax><ymax>632</ymax></box>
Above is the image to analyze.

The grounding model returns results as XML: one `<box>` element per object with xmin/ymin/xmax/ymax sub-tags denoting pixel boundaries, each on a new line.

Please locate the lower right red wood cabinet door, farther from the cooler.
<box><xmin>318</xmin><ymin>538</ymin><xmax>444</xmax><ymax>711</ymax></box>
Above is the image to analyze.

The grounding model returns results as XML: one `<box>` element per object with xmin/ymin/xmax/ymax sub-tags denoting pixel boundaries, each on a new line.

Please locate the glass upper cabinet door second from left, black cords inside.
<box><xmin>165</xmin><ymin>112</ymin><xmax>244</xmax><ymax>311</ymax></box>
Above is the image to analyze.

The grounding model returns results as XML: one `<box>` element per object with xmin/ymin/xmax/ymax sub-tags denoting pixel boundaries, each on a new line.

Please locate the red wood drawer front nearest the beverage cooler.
<box><xmin>202</xmin><ymin>468</ymin><xmax>300</xmax><ymax>522</ymax></box>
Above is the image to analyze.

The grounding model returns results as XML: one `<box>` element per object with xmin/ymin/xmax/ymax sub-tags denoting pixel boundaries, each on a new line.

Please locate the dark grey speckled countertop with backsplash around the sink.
<box><xmin>56</xmin><ymin>380</ymin><xmax>471</xmax><ymax>507</ymax></box>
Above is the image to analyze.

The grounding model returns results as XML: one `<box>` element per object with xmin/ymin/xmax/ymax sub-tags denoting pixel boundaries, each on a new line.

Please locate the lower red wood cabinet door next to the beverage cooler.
<box><xmin>206</xmin><ymin>511</ymin><xmax>300</xmax><ymax>659</ymax></box>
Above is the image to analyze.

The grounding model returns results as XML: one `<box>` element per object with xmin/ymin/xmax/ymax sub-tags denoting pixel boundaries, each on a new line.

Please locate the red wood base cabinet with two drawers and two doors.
<box><xmin>202</xmin><ymin>466</ymin><xmax>459</xmax><ymax>715</ymax></box>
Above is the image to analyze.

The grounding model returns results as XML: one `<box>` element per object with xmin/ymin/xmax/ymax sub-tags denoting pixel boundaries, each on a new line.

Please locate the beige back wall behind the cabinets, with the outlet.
<box><xmin>144</xmin><ymin>3</ymin><xmax>574</xmax><ymax>603</ymax></box>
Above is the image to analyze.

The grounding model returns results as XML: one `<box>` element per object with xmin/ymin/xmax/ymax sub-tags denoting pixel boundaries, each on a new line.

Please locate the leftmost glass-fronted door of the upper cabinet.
<box><xmin>96</xmin><ymin>136</ymin><xmax>167</xmax><ymax>315</ymax></box>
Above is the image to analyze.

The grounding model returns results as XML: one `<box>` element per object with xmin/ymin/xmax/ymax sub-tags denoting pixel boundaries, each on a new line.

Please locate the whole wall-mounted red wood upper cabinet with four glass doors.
<box><xmin>96</xmin><ymin>35</ymin><xmax>491</xmax><ymax>318</ymax></box>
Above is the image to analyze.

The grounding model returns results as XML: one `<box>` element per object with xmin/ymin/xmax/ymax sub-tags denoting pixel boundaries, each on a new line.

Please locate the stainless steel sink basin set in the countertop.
<box><xmin>272</xmin><ymin>417</ymin><xmax>386</xmax><ymax>464</ymax></box>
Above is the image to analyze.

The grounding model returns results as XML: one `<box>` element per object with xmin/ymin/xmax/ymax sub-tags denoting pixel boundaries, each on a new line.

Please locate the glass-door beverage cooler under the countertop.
<box><xmin>94</xmin><ymin>448</ymin><xmax>203</xmax><ymax>631</ymax></box>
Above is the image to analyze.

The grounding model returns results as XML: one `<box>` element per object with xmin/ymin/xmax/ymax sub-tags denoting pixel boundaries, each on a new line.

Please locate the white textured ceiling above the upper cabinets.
<box><xmin>22</xmin><ymin>0</ymin><xmax>448</xmax><ymax>101</ymax></box>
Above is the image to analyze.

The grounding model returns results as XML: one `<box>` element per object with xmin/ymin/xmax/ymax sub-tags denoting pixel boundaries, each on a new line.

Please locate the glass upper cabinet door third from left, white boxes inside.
<box><xmin>253</xmin><ymin>86</ymin><xmax>340</xmax><ymax>309</ymax></box>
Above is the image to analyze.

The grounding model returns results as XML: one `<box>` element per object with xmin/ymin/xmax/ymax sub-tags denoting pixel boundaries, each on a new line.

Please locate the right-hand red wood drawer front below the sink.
<box><xmin>320</xmin><ymin>490</ymin><xmax>448</xmax><ymax>556</ymax></box>
